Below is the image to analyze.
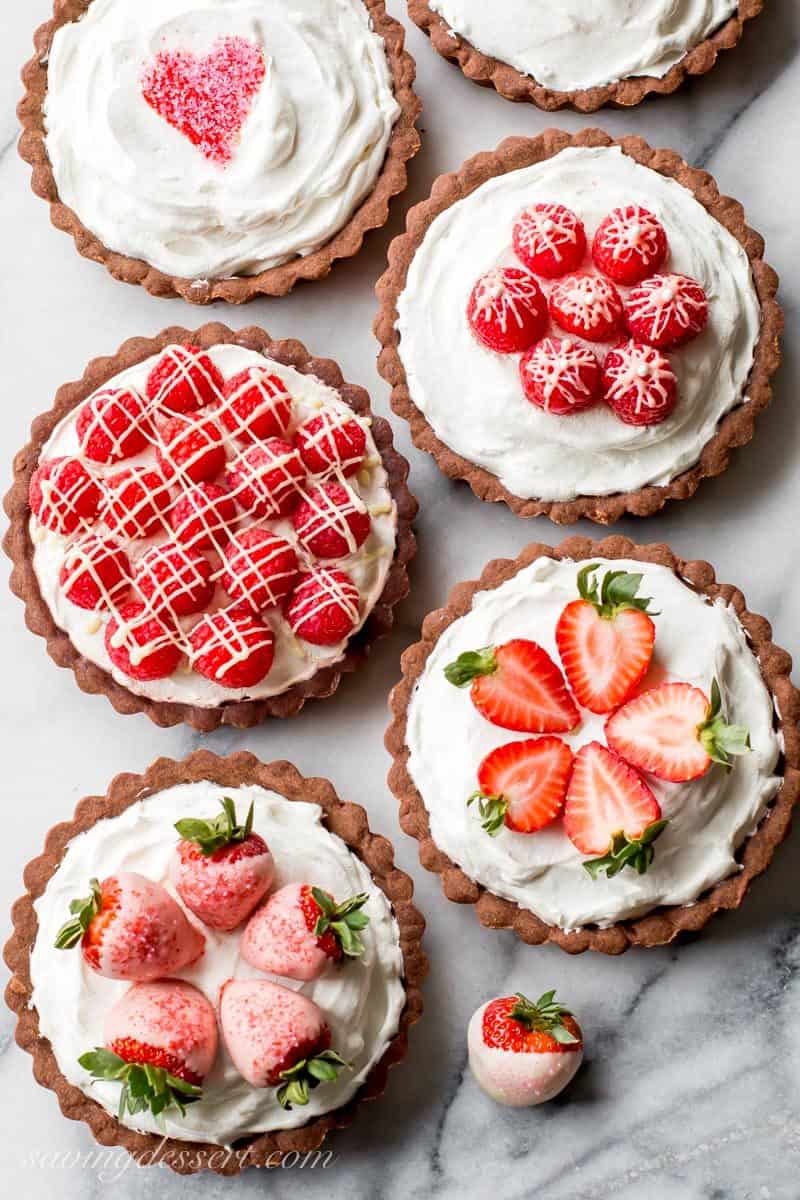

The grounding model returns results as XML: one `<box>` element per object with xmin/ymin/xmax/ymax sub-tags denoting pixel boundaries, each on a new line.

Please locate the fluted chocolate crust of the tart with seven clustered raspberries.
<box><xmin>373</xmin><ymin>128</ymin><xmax>783</xmax><ymax>524</ymax></box>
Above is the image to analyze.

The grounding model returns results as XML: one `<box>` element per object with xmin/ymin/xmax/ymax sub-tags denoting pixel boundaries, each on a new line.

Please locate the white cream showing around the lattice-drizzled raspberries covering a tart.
<box><xmin>30</xmin><ymin>344</ymin><xmax>397</xmax><ymax>708</ymax></box>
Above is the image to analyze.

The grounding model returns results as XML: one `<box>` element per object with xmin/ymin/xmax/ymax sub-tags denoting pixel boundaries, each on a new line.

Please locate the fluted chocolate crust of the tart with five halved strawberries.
<box><xmin>386</xmin><ymin>536</ymin><xmax>800</xmax><ymax>954</ymax></box>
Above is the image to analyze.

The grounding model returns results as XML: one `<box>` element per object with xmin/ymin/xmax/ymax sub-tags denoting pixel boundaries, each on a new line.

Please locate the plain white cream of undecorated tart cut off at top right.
<box><xmin>431</xmin><ymin>0</ymin><xmax>738</xmax><ymax>91</ymax></box>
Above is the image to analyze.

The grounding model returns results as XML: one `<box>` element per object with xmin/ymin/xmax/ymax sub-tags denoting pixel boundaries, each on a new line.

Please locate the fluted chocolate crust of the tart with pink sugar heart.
<box><xmin>17</xmin><ymin>0</ymin><xmax>422</xmax><ymax>305</ymax></box>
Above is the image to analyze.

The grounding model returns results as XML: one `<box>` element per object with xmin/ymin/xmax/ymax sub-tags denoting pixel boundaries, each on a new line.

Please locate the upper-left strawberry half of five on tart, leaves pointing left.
<box><xmin>445</xmin><ymin>637</ymin><xmax>581</xmax><ymax>733</ymax></box>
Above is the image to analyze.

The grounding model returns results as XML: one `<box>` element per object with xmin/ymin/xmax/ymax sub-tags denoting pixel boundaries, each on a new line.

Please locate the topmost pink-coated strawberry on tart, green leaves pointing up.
<box><xmin>170</xmin><ymin>796</ymin><xmax>275</xmax><ymax>930</ymax></box>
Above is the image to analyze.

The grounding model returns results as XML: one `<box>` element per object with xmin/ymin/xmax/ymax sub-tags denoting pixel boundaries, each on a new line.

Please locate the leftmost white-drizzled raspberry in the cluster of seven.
<box><xmin>467</xmin><ymin>266</ymin><xmax>547</xmax><ymax>354</ymax></box>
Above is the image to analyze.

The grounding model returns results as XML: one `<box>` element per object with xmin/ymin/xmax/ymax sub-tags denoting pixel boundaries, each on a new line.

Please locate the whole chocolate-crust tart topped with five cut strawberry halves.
<box><xmin>386</xmin><ymin>538</ymin><xmax>800</xmax><ymax>954</ymax></box>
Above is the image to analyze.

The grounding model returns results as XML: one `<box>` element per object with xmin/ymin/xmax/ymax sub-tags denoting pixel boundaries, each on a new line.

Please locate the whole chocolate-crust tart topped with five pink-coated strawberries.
<box><xmin>5</xmin><ymin>751</ymin><xmax>427</xmax><ymax>1175</ymax></box>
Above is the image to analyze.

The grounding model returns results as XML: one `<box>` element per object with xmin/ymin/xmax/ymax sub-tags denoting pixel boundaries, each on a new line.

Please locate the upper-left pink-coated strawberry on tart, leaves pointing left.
<box><xmin>55</xmin><ymin>871</ymin><xmax>205</xmax><ymax>979</ymax></box>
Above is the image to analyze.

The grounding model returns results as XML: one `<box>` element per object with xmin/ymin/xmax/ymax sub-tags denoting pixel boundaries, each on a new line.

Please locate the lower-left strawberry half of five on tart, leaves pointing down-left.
<box><xmin>467</xmin><ymin>738</ymin><xmax>572</xmax><ymax>838</ymax></box>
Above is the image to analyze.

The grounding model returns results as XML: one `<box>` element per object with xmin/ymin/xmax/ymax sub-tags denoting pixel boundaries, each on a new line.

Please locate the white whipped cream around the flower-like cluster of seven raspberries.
<box><xmin>397</xmin><ymin>146</ymin><xmax>760</xmax><ymax>500</ymax></box>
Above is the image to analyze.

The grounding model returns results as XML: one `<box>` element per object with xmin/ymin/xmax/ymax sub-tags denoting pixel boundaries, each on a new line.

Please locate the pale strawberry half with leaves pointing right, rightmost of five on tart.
<box><xmin>606</xmin><ymin>679</ymin><xmax>750</xmax><ymax>784</ymax></box>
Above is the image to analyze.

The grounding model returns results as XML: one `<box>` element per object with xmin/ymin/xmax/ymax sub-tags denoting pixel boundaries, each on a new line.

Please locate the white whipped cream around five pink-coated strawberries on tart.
<box><xmin>31</xmin><ymin>781</ymin><xmax>405</xmax><ymax>1145</ymax></box>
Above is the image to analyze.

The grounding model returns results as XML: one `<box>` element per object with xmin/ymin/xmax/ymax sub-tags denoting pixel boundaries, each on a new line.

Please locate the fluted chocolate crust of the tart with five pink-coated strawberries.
<box><xmin>4</xmin><ymin>750</ymin><xmax>428</xmax><ymax>1175</ymax></box>
